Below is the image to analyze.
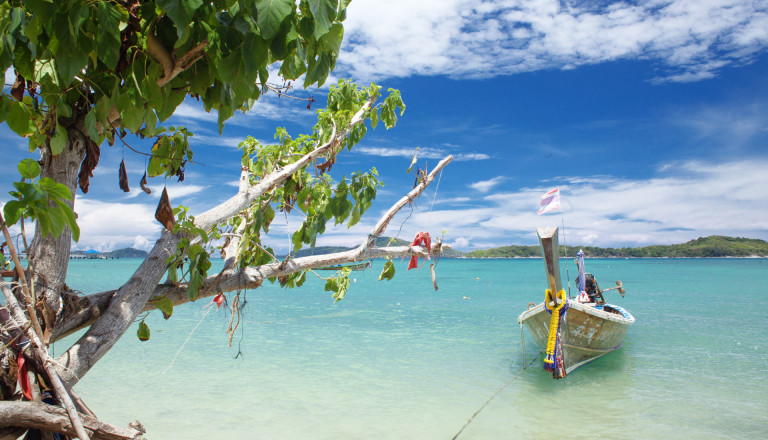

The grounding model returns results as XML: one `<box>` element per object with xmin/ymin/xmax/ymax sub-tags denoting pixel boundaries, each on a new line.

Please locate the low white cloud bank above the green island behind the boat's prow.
<box><xmin>432</xmin><ymin>159</ymin><xmax>768</xmax><ymax>247</ymax></box>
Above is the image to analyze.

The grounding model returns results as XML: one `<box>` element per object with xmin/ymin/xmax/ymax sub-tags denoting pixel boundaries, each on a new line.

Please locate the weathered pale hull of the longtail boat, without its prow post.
<box><xmin>517</xmin><ymin>300</ymin><xmax>635</xmax><ymax>373</ymax></box>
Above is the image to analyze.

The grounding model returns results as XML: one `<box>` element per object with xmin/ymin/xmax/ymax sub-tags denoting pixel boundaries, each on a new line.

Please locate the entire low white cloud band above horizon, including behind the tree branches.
<box><xmin>54</xmin><ymin>159</ymin><xmax>768</xmax><ymax>253</ymax></box>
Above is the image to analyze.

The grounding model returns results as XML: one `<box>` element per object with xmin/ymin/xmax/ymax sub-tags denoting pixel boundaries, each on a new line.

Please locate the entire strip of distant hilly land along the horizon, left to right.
<box><xmin>71</xmin><ymin>235</ymin><xmax>768</xmax><ymax>259</ymax></box>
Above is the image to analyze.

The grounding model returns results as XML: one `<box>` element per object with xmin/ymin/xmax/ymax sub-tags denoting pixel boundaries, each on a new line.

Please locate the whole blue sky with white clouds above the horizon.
<box><xmin>0</xmin><ymin>0</ymin><xmax>768</xmax><ymax>252</ymax></box>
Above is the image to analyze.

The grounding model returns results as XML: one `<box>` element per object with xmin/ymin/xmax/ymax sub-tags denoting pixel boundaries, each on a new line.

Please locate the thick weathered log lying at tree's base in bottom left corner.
<box><xmin>0</xmin><ymin>401</ymin><xmax>142</xmax><ymax>440</ymax></box>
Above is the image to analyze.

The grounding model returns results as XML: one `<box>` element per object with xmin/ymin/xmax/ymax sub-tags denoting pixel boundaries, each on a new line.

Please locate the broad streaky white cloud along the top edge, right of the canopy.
<box><xmin>339</xmin><ymin>0</ymin><xmax>768</xmax><ymax>81</ymax></box>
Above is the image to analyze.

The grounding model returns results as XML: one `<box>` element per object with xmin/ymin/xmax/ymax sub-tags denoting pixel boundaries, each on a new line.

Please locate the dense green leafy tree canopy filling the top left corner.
<box><xmin>0</xmin><ymin>0</ymin><xmax>349</xmax><ymax>182</ymax></box>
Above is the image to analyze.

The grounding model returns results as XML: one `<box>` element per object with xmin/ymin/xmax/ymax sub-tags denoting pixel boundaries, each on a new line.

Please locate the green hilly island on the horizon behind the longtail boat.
<box><xmin>465</xmin><ymin>235</ymin><xmax>768</xmax><ymax>258</ymax></box>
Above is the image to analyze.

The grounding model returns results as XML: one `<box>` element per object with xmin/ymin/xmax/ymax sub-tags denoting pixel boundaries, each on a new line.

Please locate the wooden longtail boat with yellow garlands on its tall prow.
<box><xmin>517</xmin><ymin>227</ymin><xmax>635</xmax><ymax>379</ymax></box>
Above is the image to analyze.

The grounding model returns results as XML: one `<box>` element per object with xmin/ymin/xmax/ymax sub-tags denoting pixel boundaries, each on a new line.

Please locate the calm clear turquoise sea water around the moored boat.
<box><xmin>61</xmin><ymin>259</ymin><xmax>768</xmax><ymax>440</ymax></box>
